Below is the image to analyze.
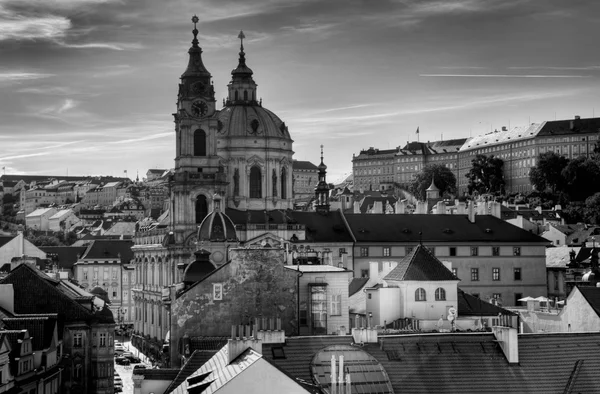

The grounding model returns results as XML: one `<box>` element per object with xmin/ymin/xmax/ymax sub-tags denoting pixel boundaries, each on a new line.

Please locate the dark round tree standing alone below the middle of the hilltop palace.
<box><xmin>465</xmin><ymin>155</ymin><xmax>506</xmax><ymax>194</ymax></box>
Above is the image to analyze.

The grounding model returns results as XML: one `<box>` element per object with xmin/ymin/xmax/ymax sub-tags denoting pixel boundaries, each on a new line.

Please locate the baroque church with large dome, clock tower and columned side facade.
<box><xmin>132</xmin><ymin>16</ymin><xmax>335</xmax><ymax>360</ymax></box>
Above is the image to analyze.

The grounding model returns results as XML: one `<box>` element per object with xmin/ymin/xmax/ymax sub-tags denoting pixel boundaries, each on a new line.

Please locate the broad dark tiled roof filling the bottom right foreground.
<box><xmin>263</xmin><ymin>332</ymin><xmax>600</xmax><ymax>394</ymax></box>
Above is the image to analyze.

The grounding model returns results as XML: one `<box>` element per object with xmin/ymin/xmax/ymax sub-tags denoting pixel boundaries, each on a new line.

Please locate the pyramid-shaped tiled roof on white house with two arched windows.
<box><xmin>383</xmin><ymin>245</ymin><xmax>459</xmax><ymax>281</ymax></box>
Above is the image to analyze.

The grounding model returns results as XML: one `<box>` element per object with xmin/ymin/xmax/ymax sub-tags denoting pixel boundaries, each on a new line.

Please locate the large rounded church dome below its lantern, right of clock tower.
<box><xmin>218</xmin><ymin>104</ymin><xmax>291</xmax><ymax>140</ymax></box>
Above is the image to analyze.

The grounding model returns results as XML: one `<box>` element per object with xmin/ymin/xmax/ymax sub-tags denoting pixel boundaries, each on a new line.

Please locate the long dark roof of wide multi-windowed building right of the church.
<box><xmin>344</xmin><ymin>214</ymin><xmax>549</xmax><ymax>244</ymax></box>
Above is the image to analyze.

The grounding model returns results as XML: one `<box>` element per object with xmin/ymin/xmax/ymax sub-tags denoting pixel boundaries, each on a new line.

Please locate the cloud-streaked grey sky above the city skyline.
<box><xmin>0</xmin><ymin>0</ymin><xmax>600</xmax><ymax>181</ymax></box>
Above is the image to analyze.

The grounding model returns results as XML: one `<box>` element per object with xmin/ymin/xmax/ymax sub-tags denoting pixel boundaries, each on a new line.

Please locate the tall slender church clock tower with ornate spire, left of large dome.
<box><xmin>170</xmin><ymin>15</ymin><xmax>227</xmax><ymax>244</ymax></box>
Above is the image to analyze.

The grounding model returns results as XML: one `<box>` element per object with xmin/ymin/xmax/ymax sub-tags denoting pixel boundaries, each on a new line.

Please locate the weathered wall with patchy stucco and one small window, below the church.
<box><xmin>171</xmin><ymin>248</ymin><xmax>297</xmax><ymax>360</ymax></box>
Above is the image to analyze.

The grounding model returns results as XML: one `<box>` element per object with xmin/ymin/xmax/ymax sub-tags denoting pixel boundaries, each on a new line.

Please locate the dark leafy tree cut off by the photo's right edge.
<box><xmin>562</xmin><ymin>156</ymin><xmax>600</xmax><ymax>201</ymax></box>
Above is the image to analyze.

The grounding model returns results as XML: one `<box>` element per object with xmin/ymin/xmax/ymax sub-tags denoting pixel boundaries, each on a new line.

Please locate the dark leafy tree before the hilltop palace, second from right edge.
<box><xmin>529</xmin><ymin>151</ymin><xmax>569</xmax><ymax>193</ymax></box>
